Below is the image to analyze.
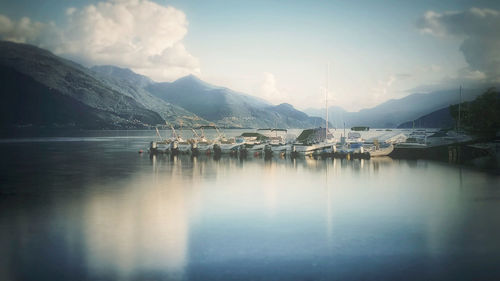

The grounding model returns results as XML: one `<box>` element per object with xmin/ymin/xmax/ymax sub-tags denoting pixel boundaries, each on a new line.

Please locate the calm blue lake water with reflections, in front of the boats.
<box><xmin>0</xmin><ymin>130</ymin><xmax>500</xmax><ymax>280</ymax></box>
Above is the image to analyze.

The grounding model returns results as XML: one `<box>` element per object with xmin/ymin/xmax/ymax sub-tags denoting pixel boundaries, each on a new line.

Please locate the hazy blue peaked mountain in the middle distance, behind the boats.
<box><xmin>146</xmin><ymin>75</ymin><xmax>324</xmax><ymax>128</ymax></box>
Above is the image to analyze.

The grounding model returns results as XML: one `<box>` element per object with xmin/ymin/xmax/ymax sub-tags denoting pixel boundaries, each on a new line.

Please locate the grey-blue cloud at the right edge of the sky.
<box><xmin>417</xmin><ymin>8</ymin><xmax>500</xmax><ymax>82</ymax></box>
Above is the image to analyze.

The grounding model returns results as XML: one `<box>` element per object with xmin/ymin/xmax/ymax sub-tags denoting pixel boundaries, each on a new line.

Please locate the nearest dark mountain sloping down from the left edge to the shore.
<box><xmin>0</xmin><ymin>41</ymin><xmax>207</xmax><ymax>129</ymax></box>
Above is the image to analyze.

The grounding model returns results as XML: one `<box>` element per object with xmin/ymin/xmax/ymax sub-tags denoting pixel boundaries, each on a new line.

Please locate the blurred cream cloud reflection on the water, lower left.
<box><xmin>84</xmin><ymin>173</ymin><xmax>190</xmax><ymax>279</ymax></box>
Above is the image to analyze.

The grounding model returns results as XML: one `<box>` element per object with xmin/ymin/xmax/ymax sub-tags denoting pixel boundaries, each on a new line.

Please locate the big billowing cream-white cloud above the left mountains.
<box><xmin>0</xmin><ymin>0</ymin><xmax>200</xmax><ymax>81</ymax></box>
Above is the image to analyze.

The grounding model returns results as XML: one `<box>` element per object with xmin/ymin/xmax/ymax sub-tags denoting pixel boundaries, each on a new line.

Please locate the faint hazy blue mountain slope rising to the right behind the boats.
<box><xmin>305</xmin><ymin>89</ymin><xmax>483</xmax><ymax>128</ymax></box>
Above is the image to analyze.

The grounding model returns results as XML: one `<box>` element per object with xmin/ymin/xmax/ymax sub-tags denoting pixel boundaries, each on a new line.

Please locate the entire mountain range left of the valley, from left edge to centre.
<box><xmin>0</xmin><ymin>41</ymin><xmax>324</xmax><ymax>129</ymax></box>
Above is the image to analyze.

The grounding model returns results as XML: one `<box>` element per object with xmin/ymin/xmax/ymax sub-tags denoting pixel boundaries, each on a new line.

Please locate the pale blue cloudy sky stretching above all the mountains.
<box><xmin>0</xmin><ymin>0</ymin><xmax>500</xmax><ymax>110</ymax></box>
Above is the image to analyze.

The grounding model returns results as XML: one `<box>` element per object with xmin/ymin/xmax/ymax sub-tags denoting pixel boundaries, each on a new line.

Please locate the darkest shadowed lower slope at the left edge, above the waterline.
<box><xmin>0</xmin><ymin>66</ymin><xmax>155</xmax><ymax>130</ymax></box>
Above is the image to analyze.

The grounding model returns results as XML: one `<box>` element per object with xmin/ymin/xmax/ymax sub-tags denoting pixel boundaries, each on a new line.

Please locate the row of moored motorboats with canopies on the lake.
<box><xmin>149</xmin><ymin>126</ymin><xmax>434</xmax><ymax>158</ymax></box>
